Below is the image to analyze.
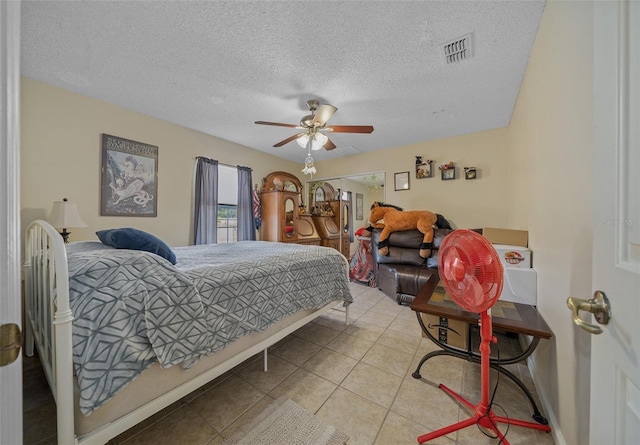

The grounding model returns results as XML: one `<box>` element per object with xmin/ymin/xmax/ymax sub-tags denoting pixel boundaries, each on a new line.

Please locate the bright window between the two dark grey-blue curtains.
<box><xmin>216</xmin><ymin>165</ymin><xmax>238</xmax><ymax>244</ymax></box>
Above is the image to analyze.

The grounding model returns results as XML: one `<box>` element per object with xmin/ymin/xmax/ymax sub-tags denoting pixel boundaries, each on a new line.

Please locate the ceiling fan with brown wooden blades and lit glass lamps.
<box><xmin>256</xmin><ymin>99</ymin><xmax>373</xmax><ymax>150</ymax></box>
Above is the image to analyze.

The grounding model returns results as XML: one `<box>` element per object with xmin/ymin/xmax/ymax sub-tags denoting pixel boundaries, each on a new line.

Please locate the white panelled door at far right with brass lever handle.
<box><xmin>583</xmin><ymin>1</ymin><xmax>640</xmax><ymax>445</ymax></box>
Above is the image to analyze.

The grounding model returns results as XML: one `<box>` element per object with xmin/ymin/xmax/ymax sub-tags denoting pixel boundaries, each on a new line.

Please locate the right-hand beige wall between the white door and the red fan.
<box><xmin>508</xmin><ymin>1</ymin><xmax>594</xmax><ymax>444</ymax></box>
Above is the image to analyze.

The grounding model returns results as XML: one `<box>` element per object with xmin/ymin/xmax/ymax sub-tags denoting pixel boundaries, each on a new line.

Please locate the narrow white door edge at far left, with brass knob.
<box><xmin>0</xmin><ymin>1</ymin><xmax>22</xmax><ymax>444</ymax></box>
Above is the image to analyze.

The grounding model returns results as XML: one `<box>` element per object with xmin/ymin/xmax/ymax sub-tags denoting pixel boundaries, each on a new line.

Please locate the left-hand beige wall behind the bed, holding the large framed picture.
<box><xmin>20</xmin><ymin>77</ymin><xmax>300</xmax><ymax>246</ymax></box>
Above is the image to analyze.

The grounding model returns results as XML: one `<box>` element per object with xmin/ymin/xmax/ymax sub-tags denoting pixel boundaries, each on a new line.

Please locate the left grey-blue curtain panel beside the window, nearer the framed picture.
<box><xmin>193</xmin><ymin>157</ymin><xmax>218</xmax><ymax>245</ymax></box>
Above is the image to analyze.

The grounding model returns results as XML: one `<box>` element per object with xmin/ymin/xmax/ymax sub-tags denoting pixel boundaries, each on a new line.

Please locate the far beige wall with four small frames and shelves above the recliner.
<box><xmin>316</xmin><ymin>129</ymin><xmax>510</xmax><ymax>228</ymax></box>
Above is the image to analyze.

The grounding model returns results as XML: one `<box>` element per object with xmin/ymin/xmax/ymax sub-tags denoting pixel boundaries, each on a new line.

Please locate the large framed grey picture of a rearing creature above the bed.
<box><xmin>100</xmin><ymin>134</ymin><xmax>158</xmax><ymax>216</ymax></box>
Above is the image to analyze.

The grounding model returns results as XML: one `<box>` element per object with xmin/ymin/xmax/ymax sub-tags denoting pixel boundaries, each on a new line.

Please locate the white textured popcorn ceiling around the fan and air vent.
<box><xmin>21</xmin><ymin>0</ymin><xmax>545</xmax><ymax>162</ymax></box>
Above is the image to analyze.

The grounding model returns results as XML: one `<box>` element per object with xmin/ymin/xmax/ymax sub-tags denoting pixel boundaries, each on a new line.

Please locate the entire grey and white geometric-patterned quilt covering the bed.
<box><xmin>67</xmin><ymin>241</ymin><xmax>352</xmax><ymax>415</ymax></box>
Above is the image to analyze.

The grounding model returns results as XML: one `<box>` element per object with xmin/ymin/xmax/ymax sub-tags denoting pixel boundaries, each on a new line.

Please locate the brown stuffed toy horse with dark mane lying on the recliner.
<box><xmin>367</xmin><ymin>202</ymin><xmax>451</xmax><ymax>258</ymax></box>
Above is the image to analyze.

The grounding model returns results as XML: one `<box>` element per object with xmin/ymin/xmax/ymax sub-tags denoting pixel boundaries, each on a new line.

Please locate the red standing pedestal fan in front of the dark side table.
<box><xmin>418</xmin><ymin>229</ymin><xmax>551</xmax><ymax>445</ymax></box>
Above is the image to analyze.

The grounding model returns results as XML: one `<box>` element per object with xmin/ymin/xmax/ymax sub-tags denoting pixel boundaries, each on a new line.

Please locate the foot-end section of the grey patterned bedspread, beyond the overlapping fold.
<box><xmin>175</xmin><ymin>241</ymin><xmax>352</xmax><ymax>350</ymax></box>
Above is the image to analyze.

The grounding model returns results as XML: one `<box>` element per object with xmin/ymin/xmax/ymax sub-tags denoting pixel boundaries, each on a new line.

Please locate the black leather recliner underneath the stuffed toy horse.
<box><xmin>371</xmin><ymin>229</ymin><xmax>453</xmax><ymax>304</ymax></box>
